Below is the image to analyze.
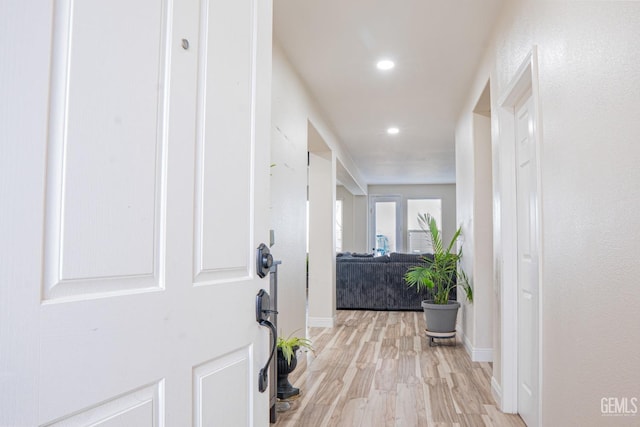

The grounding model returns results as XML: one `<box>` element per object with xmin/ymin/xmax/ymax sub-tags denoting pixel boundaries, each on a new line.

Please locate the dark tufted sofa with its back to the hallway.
<box><xmin>336</xmin><ymin>252</ymin><xmax>456</xmax><ymax>311</ymax></box>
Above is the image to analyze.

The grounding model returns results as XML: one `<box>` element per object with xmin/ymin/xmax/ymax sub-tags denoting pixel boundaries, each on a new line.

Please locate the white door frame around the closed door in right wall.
<box><xmin>492</xmin><ymin>45</ymin><xmax>544</xmax><ymax>425</ymax></box>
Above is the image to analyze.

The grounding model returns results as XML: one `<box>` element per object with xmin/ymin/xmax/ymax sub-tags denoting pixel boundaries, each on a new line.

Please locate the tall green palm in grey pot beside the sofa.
<box><xmin>404</xmin><ymin>214</ymin><xmax>473</xmax><ymax>338</ymax></box>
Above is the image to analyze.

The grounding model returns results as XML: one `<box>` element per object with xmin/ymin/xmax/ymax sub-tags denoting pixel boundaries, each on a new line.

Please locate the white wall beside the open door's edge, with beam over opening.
<box><xmin>271</xmin><ymin>41</ymin><xmax>366</xmax><ymax>335</ymax></box>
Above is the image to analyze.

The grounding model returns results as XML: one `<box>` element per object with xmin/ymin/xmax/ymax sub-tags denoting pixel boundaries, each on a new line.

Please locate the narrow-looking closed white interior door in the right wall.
<box><xmin>515</xmin><ymin>93</ymin><xmax>539</xmax><ymax>426</ymax></box>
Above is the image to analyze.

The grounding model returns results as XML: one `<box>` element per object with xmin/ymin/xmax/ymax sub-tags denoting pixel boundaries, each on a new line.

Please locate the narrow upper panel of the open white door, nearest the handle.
<box><xmin>194</xmin><ymin>0</ymin><xmax>257</xmax><ymax>285</ymax></box>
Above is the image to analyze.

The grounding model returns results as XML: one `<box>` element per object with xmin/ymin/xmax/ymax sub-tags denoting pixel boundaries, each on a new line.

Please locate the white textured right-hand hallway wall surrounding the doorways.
<box><xmin>456</xmin><ymin>0</ymin><xmax>640</xmax><ymax>426</ymax></box>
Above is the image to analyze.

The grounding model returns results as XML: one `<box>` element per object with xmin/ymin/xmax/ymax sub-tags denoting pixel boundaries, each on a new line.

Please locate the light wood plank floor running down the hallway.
<box><xmin>275</xmin><ymin>310</ymin><xmax>524</xmax><ymax>427</ymax></box>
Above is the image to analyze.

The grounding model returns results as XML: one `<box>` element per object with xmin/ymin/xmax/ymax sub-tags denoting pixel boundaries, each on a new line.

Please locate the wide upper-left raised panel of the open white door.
<box><xmin>42</xmin><ymin>0</ymin><xmax>169</xmax><ymax>302</ymax></box>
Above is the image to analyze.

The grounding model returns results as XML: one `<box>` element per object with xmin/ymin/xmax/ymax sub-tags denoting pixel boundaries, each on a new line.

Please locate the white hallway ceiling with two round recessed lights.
<box><xmin>274</xmin><ymin>0</ymin><xmax>505</xmax><ymax>184</ymax></box>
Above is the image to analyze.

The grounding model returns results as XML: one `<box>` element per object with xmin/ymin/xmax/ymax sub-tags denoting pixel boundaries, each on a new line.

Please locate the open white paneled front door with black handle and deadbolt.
<box><xmin>0</xmin><ymin>0</ymin><xmax>271</xmax><ymax>426</ymax></box>
